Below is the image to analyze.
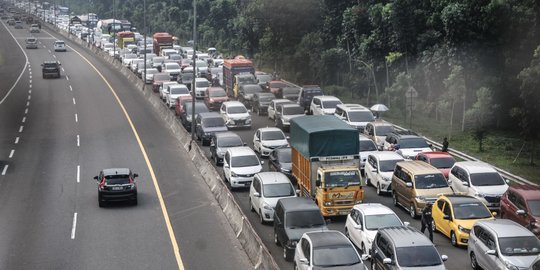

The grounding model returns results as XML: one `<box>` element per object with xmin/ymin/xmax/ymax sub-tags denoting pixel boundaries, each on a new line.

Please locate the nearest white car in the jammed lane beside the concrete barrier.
<box><xmin>249</xmin><ymin>172</ymin><xmax>296</xmax><ymax>224</ymax></box>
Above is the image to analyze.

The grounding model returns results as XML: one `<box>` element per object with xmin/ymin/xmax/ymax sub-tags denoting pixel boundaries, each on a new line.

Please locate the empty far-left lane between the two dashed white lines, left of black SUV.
<box><xmin>0</xmin><ymin>40</ymin><xmax>77</xmax><ymax>269</ymax></box>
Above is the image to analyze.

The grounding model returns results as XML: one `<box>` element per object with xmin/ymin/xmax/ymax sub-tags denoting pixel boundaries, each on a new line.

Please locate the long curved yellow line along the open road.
<box><xmin>53</xmin><ymin>34</ymin><xmax>184</xmax><ymax>270</ymax></box>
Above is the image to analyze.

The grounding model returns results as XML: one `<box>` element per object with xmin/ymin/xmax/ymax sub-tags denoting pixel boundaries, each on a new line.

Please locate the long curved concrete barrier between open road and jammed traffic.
<box><xmin>47</xmin><ymin>24</ymin><xmax>279</xmax><ymax>270</ymax></box>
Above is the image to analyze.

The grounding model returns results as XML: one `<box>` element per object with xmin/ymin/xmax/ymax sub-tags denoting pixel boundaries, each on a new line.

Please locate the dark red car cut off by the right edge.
<box><xmin>500</xmin><ymin>185</ymin><xmax>540</xmax><ymax>239</ymax></box>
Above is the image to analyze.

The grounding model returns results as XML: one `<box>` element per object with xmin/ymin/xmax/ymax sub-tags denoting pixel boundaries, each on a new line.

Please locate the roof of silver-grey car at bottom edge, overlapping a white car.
<box><xmin>379</xmin><ymin>226</ymin><xmax>433</xmax><ymax>248</ymax></box>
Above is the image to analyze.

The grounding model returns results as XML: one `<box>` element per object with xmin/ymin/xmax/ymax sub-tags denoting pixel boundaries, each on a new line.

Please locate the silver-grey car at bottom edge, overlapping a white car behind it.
<box><xmin>370</xmin><ymin>226</ymin><xmax>448</xmax><ymax>270</ymax></box>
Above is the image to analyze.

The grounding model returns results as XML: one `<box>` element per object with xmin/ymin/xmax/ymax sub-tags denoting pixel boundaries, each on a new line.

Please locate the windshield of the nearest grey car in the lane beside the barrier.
<box><xmin>313</xmin><ymin>245</ymin><xmax>361</xmax><ymax>267</ymax></box>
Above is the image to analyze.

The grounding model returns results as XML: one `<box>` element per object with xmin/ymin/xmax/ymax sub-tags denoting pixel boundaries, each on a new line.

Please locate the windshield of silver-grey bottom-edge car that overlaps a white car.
<box><xmin>396</xmin><ymin>246</ymin><xmax>442</xmax><ymax>267</ymax></box>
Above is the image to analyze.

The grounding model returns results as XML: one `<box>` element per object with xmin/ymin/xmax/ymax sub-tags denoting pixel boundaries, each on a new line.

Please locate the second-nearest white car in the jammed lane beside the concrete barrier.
<box><xmin>223</xmin><ymin>146</ymin><xmax>264</xmax><ymax>189</ymax></box>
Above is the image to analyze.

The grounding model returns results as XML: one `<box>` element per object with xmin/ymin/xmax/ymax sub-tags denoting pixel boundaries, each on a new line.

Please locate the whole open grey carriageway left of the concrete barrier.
<box><xmin>0</xmin><ymin>20</ymin><xmax>251</xmax><ymax>269</ymax></box>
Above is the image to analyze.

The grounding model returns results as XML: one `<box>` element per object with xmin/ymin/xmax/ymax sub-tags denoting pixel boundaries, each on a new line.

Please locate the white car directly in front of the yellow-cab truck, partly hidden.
<box><xmin>345</xmin><ymin>203</ymin><xmax>409</xmax><ymax>255</ymax></box>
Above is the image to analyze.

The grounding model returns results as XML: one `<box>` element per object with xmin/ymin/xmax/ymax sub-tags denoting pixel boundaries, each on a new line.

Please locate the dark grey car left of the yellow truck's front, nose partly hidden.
<box><xmin>274</xmin><ymin>197</ymin><xmax>328</xmax><ymax>261</ymax></box>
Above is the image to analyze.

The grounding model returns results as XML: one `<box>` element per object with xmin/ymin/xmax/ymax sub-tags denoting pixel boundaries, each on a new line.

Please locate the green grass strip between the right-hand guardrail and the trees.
<box><xmin>382</xmin><ymin>112</ymin><xmax>540</xmax><ymax>184</ymax></box>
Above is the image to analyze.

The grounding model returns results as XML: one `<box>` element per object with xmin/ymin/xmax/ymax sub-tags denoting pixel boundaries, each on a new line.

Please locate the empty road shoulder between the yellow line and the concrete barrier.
<box><xmin>41</xmin><ymin>28</ymin><xmax>251</xmax><ymax>269</ymax></box>
